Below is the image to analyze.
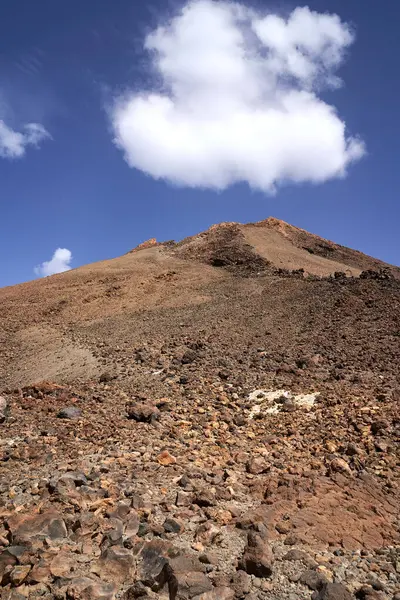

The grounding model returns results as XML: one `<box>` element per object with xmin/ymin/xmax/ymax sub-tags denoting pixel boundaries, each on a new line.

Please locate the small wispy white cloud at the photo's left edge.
<box><xmin>0</xmin><ymin>119</ymin><xmax>50</xmax><ymax>158</ymax></box>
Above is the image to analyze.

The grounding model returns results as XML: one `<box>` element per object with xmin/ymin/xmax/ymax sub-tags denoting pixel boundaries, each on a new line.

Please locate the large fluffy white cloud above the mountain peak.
<box><xmin>110</xmin><ymin>0</ymin><xmax>365</xmax><ymax>193</ymax></box>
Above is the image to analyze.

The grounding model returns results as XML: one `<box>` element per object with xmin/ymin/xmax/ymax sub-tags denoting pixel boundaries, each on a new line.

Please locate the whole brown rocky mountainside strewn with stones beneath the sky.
<box><xmin>0</xmin><ymin>218</ymin><xmax>400</xmax><ymax>600</ymax></box>
